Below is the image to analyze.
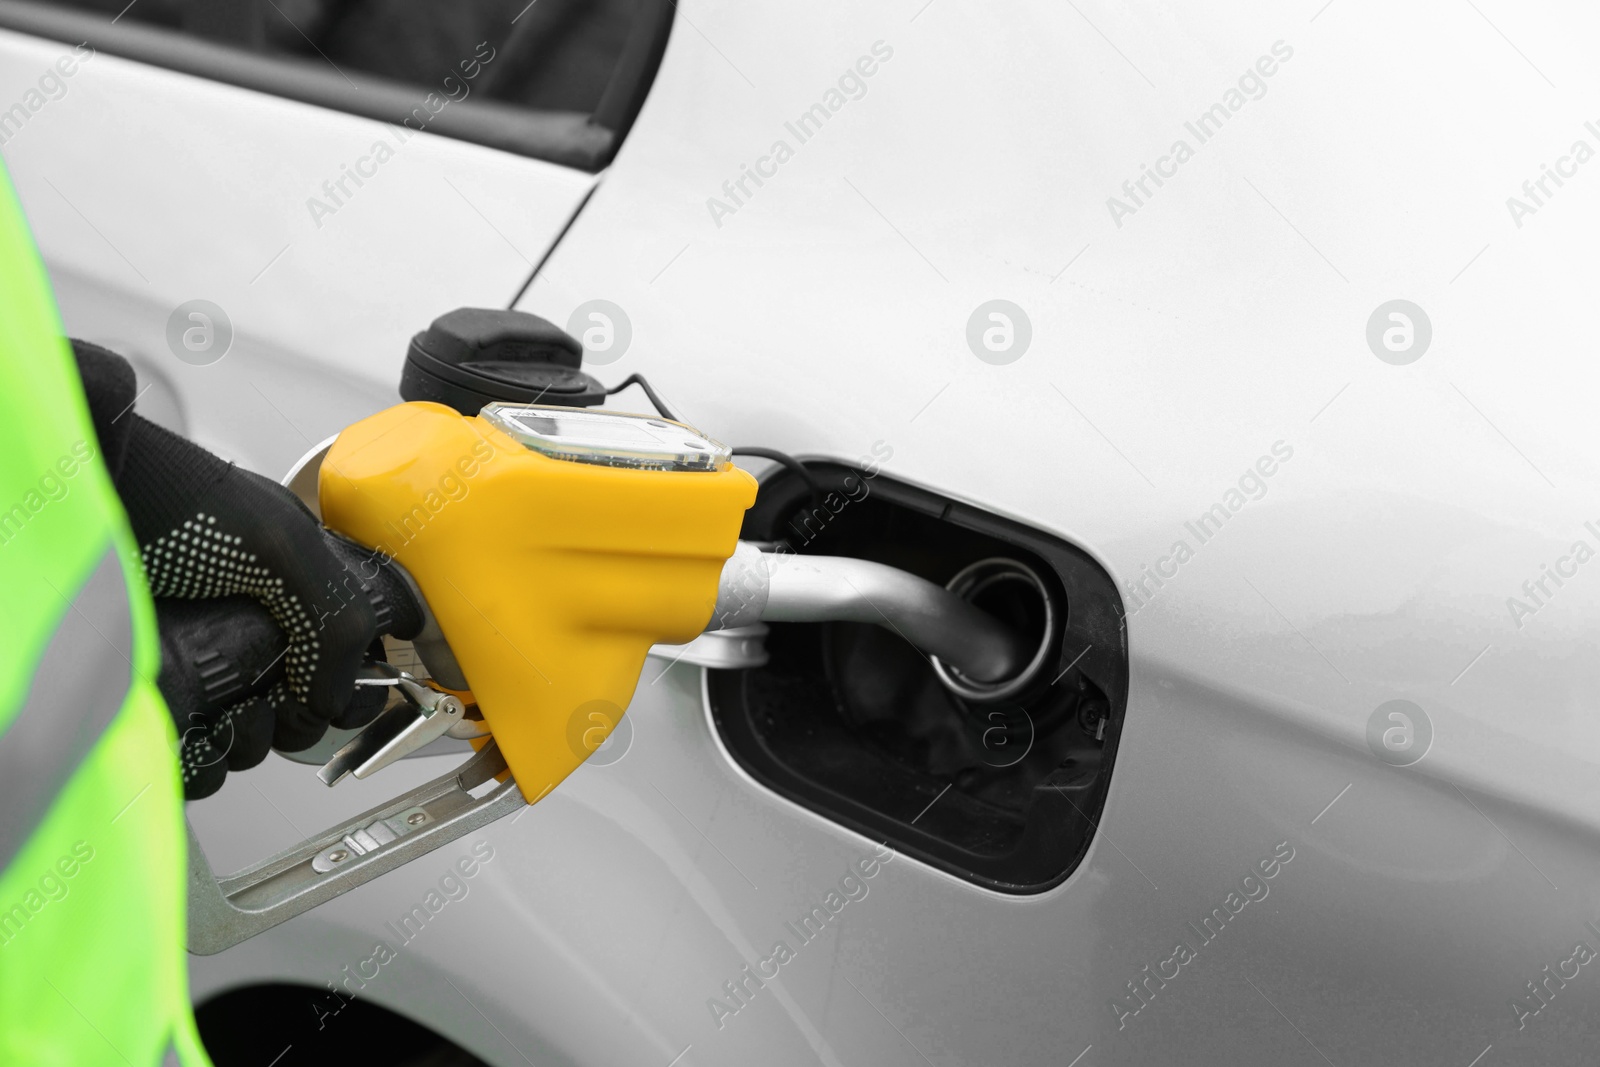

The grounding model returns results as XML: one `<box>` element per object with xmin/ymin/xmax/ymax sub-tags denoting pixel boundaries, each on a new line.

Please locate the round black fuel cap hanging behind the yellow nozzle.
<box><xmin>400</xmin><ymin>307</ymin><xmax>606</xmax><ymax>414</ymax></box>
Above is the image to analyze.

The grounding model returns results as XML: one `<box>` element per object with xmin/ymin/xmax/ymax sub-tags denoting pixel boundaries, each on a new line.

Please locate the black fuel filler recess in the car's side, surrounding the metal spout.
<box><xmin>707</xmin><ymin>462</ymin><xmax>1128</xmax><ymax>893</ymax></box>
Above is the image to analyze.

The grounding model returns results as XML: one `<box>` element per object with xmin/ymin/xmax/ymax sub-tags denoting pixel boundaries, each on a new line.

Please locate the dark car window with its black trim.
<box><xmin>0</xmin><ymin>0</ymin><xmax>670</xmax><ymax>170</ymax></box>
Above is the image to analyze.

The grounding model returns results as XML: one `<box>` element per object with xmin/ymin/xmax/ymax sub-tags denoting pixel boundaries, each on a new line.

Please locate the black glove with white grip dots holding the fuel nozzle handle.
<box><xmin>72</xmin><ymin>341</ymin><xmax>412</xmax><ymax>798</ymax></box>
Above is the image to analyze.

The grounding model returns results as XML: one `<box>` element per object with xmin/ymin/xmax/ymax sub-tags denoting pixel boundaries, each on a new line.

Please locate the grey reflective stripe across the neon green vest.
<box><xmin>0</xmin><ymin>549</ymin><xmax>133</xmax><ymax>870</ymax></box>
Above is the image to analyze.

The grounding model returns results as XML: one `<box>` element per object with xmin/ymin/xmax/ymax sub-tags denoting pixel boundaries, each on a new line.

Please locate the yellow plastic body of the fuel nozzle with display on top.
<box><xmin>318</xmin><ymin>403</ymin><xmax>755</xmax><ymax>801</ymax></box>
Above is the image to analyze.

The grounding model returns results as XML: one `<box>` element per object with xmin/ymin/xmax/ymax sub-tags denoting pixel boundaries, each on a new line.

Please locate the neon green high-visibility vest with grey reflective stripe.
<box><xmin>0</xmin><ymin>170</ymin><xmax>210</xmax><ymax>1067</ymax></box>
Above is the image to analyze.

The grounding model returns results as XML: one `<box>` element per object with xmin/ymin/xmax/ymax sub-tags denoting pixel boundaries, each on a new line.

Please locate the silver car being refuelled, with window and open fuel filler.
<box><xmin>0</xmin><ymin>0</ymin><xmax>1600</xmax><ymax>1067</ymax></box>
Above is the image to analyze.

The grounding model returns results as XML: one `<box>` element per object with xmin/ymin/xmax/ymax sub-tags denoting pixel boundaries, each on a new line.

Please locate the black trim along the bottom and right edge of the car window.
<box><xmin>0</xmin><ymin>0</ymin><xmax>672</xmax><ymax>173</ymax></box>
